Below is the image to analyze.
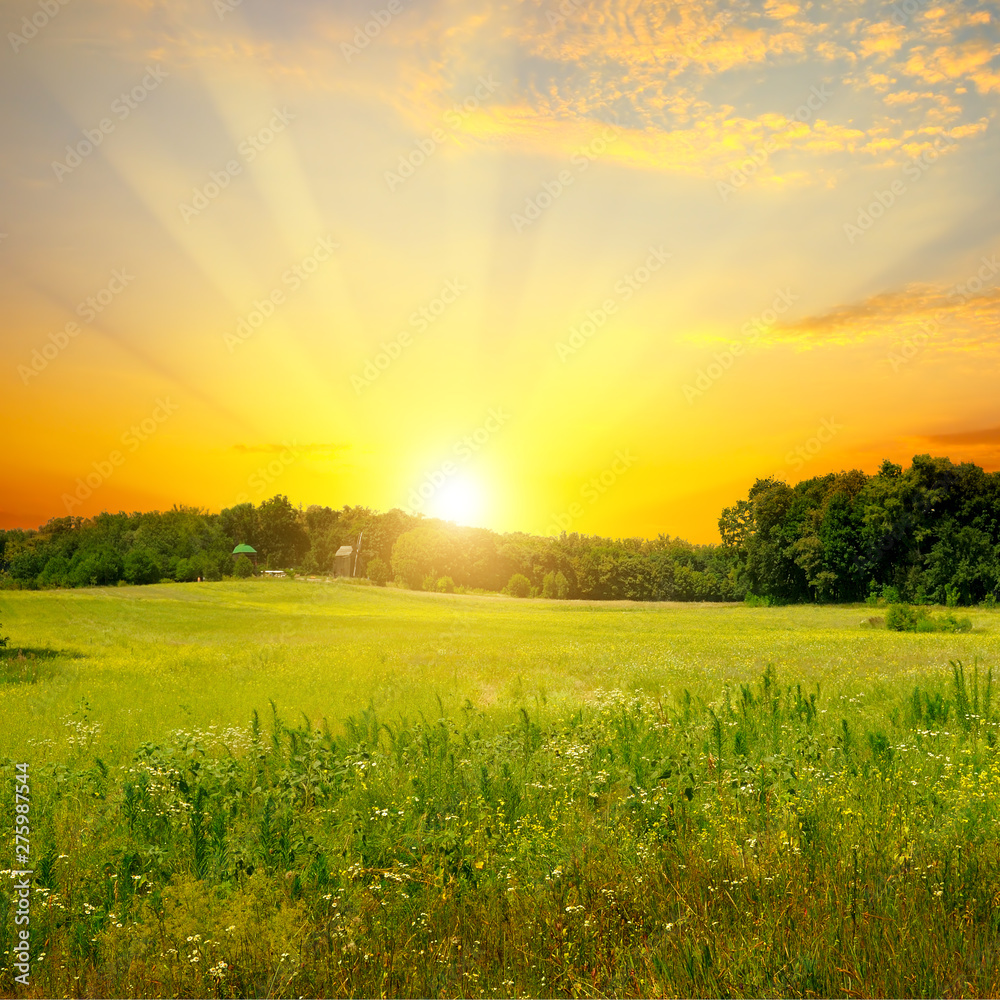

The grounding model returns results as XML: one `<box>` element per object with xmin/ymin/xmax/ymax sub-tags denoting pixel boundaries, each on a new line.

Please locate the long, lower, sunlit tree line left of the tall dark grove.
<box><xmin>0</xmin><ymin>495</ymin><xmax>742</xmax><ymax>601</ymax></box>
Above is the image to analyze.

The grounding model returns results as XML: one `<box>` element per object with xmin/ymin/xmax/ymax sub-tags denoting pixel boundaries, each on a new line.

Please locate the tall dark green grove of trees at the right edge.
<box><xmin>719</xmin><ymin>455</ymin><xmax>1000</xmax><ymax>606</ymax></box>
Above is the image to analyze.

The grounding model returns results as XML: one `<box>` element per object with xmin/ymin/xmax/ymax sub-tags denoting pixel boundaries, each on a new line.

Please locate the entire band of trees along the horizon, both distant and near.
<box><xmin>0</xmin><ymin>455</ymin><xmax>1000</xmax><ymax>605</ymax></box>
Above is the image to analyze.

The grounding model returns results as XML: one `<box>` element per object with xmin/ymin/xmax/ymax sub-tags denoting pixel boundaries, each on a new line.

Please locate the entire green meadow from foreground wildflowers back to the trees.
<box><xmin>0</xmin><ymin>580</ymin><xmax>1000</xmax><ymax>996</ymax></box>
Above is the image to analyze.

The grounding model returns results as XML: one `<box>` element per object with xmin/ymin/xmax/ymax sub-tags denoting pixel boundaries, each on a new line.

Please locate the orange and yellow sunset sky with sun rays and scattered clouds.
<box><xmin>0</xmin><ymin>0</ymin><xmax>1000</xmax><ymax>541</ymax></box>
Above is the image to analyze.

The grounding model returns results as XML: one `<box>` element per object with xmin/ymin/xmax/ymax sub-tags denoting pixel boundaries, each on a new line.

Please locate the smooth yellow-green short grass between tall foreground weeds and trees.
<box><xmin>0</xmin><ymin>581</ymin><xmax>1000</xmax><ymax>757</ymax></box>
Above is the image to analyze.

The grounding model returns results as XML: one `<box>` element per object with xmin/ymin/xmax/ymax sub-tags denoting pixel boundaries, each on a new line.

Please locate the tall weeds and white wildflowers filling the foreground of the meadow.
<box><xmin>0</xmin><ymin>665</ymin><xmax>1000</xmax><ymax>996</ymax></box>
